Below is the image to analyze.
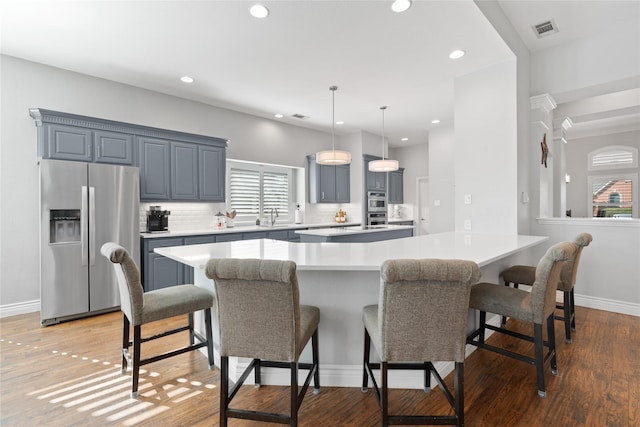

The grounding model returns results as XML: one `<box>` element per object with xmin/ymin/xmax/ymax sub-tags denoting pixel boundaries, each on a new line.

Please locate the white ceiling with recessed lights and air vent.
<box><xmin>0</xmin><ymin>0</ymin><xmax>637</xmax><ymax>146</ymax></box>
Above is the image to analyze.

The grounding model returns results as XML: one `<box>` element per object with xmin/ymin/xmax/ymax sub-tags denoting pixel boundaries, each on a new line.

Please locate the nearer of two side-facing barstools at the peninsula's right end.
<box><xmin>467</xmin><ymin>242</ymin><xmax>577</xmax><ymax>397</ymax></box>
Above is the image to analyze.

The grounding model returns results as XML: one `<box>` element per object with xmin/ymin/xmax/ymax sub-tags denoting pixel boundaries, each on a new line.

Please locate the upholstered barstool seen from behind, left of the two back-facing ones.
<box><xmin>206</xmin><ymin>259</ymin><xmax>320</xmax><ymax>427</ymax></box>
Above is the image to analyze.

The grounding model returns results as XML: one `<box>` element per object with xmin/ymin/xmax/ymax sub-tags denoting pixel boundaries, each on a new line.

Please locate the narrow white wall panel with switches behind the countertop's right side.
<box><xmin>454</xmin><ymin>59</ymin><xmax>518</xmax><ymax>234</ymax></box>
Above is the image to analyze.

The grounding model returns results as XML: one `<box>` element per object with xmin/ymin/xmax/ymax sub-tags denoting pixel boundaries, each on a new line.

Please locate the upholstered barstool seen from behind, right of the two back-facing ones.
<box><xmin>362</xmin><ymin>259</ymin><xmax>480</xmax><ymax>426</ymax></box>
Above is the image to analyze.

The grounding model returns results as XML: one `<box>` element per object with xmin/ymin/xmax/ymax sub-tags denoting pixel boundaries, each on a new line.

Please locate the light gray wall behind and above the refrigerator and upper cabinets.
<box><xmin>0</xmin><ymin>56</ymin><xmax>344</xmax><ymax>307</ymax></box>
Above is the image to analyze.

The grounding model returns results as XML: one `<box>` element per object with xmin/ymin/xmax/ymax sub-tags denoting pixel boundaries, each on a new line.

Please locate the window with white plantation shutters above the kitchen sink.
<box><xmin>227</xmin><ymin>160</ymin><xmax>294</xmax><ymax>222</ymax></box>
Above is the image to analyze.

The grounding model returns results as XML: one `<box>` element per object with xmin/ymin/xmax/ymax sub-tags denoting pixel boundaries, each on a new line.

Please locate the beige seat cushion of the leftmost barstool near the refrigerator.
<box><xmin>142</xmin><ymin>285</ymin><xmax>214</xmax><ymax>325</ymax></box>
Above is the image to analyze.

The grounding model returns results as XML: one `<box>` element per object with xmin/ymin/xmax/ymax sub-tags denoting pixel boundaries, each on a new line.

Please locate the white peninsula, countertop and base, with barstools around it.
<box><xmin>155</xmin><ymin>232</ymin><xmax>548</xmax><ymax>388</ymax></box>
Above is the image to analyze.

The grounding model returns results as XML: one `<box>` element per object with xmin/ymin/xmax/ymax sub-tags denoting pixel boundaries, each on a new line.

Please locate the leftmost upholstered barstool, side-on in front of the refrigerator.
<box><xmin>101</xmin><ymin>242</ymin><xmax>214</xmax><ymax>398</ymax></box>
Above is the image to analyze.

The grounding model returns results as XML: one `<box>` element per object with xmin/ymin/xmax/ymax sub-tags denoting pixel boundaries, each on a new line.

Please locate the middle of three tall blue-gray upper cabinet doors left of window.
<box><xmin>171</xmin><ymin>142</ymin><xmax>198</xmax><ymax>200</ymax></box>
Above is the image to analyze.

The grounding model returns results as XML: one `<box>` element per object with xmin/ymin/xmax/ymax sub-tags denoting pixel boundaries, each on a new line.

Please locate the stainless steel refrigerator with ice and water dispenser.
<box><xmin>40</xmin><ymin>160</ymin><xmax>140</xmax><ymax>325</ymax></box>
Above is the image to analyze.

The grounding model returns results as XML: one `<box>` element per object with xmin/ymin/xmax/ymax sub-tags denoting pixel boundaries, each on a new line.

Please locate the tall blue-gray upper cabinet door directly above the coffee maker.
<box><xmin>138</xmin><ymin>137</ymin><xmax>170</xmax><ymax>200</ymax></box>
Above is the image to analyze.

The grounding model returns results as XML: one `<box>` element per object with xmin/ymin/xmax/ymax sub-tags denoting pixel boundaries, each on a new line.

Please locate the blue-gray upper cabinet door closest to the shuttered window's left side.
<box><xmin>198</xmin><ymin>146</ymin><xmax>226</xmax><ymax>202</ymax></box>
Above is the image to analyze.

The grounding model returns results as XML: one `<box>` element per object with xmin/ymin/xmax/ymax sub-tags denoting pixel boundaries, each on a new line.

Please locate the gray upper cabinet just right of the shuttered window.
<box><xmin>307</xmin><ymin>155</ymin><xmax>351</xmax><ymax>203</ymax></box>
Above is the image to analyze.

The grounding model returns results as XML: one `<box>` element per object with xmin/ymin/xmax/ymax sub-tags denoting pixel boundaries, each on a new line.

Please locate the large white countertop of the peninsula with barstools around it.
<box><xmin>154</xmin><ymin>232</ymin><xmax>548</xmax><ymax>271</ymax></box>
